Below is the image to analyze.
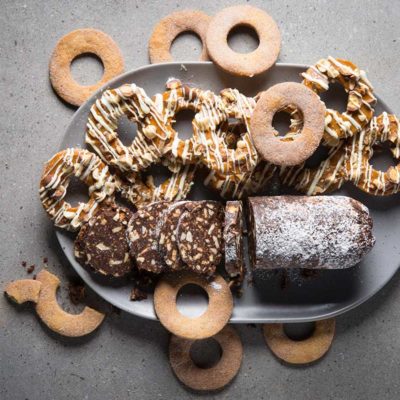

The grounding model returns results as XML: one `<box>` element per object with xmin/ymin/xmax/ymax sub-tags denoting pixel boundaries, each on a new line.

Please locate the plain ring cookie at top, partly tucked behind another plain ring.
<box><xmin>149</xmin><ymin>10</ymin><xmax>211</xmax><ymax>64</ymax></box>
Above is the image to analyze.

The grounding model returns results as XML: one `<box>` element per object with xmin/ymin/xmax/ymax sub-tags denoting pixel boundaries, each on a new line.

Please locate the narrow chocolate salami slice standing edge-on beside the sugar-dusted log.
<box><xmin>223</xmin><ymin>201</ymin><xmax>245</xmax><ymax>286</ymax></box>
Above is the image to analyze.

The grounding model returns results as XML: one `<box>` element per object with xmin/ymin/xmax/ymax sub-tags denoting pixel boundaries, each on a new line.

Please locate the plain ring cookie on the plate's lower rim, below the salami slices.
<box><xmin>154</xmin><ymin>271</ymin><xmax>233</xmax><ymax>340</ymax></box>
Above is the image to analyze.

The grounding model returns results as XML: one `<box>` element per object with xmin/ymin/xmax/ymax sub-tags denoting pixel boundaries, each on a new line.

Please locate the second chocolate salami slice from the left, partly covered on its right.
<box><xmin>127</xmin><ymin>201</ymin><xmax>170</xmax><ymax>274</ymax></box>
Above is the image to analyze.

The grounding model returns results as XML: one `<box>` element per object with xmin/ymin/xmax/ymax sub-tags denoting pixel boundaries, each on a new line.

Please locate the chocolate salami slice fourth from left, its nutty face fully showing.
<box><xmin>177</xmin><ymin>201</ymin><xmax>223</xmax><ymax>275</ymax></box>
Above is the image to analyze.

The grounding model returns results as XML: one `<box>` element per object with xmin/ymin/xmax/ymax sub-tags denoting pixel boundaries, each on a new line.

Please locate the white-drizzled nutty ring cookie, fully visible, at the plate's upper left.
<box><xmin>85</xmin><ymin>83</ymin><xmax>171</xmax><ymax>174</ymax></box>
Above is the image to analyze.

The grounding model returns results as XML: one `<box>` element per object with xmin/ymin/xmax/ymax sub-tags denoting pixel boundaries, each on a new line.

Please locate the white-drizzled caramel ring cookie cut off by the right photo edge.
<box><xmin>346</xmin><ymin>112</ymin><xmax>400</xmax><ymax>196</ymax></box>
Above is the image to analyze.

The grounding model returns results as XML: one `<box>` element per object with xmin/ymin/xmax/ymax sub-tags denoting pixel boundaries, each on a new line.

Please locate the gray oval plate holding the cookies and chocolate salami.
<box><xmin>56</xmin><ymin>62</ymin><xmax>400</xmax><ymax>323</ymax></box>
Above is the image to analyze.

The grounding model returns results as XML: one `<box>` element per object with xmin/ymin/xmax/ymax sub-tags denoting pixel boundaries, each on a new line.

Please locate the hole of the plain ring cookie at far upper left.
<box><xmin>71</xmin><ymin>53</ymin><xmax>104</xmax><ymax>86</ymax></box>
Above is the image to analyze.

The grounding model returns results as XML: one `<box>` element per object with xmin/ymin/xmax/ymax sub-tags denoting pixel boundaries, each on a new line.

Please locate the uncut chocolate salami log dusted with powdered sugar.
<box><xmin>248</xmin><ymin>196</ymin><xmax>375</xmax><ymax>270</ymax></box>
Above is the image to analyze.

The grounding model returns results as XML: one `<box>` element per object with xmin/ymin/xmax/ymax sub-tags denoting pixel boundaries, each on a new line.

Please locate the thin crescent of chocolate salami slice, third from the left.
<box><xmin>158</xmin><ymin>201</ymin><xmax>197</xmax><ymax>271</ymax></box>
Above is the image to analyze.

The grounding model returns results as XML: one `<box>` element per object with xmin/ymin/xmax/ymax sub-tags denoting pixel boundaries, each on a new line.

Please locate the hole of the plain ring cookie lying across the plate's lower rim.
<box><xmin>176</xmin><ymin>284</ymin><xmax>208</xmax><ymax>318</ymax></box>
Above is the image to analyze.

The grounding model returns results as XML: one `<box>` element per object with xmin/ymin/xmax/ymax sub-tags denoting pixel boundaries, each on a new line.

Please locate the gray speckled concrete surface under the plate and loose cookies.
<box><xmin>0</xmin><ymin>0</ymin><xmax>400</xmax><ymax>400</ymax></box>
